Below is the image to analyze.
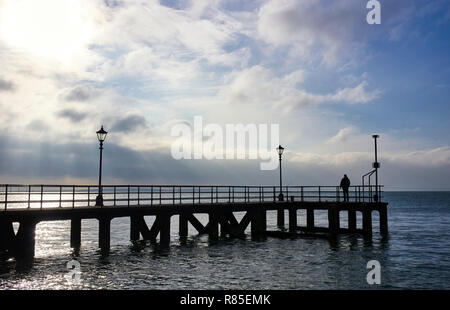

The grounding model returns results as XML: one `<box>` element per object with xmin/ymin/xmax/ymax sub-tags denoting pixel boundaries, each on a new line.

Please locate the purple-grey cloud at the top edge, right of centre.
<box><xmin>257</xmin><ymin>0</ymin><xmax>413</xmax><ymax>64</ymax></box>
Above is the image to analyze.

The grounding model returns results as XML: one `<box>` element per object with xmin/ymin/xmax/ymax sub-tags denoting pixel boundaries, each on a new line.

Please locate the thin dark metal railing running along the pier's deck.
<box><xmin>0</xmin><ymin>184</ymin><xmax>383</xmax><ymax>211</ymax></box>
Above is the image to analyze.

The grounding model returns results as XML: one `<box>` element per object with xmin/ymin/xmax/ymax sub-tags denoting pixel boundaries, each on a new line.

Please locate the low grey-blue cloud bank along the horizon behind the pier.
<box><xmin>0</xmin><ymin>136</ymin><xmax>450</xmax><ymax>190</ymax></box>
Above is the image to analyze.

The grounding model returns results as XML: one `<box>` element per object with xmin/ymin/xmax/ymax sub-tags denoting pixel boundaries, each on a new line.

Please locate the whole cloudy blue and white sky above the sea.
<box><xmin>0</xmin><ymin>0</ymin><xmax>450</xmax><ymax>190</ymax></box>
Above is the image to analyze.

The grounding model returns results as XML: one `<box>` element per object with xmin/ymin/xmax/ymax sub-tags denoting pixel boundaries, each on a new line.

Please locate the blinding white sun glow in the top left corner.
<box><xmin>0</xmin><ymin>0</ymin><xmax>92</xmax><ymax>63</ymax></box>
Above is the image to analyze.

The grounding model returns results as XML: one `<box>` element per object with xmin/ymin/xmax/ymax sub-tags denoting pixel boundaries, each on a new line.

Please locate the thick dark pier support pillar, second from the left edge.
<box><xmin>14</xmin><ymin>219</ymin><xmax>36</xmax><ymax>260</ymax></box>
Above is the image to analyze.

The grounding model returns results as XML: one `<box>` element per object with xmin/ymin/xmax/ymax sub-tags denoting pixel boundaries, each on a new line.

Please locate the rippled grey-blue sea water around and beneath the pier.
<box><xmin>0</xmin><ymin>192</ymin><xmax>450</xmax><ymax>289</ymax></box>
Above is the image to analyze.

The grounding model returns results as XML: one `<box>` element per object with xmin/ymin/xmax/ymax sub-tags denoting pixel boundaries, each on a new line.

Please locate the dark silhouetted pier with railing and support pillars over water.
<box><xmin>0</xmin><ymin>184</ymin><xmax>388</xmax><ymax>259</ymax></box>
